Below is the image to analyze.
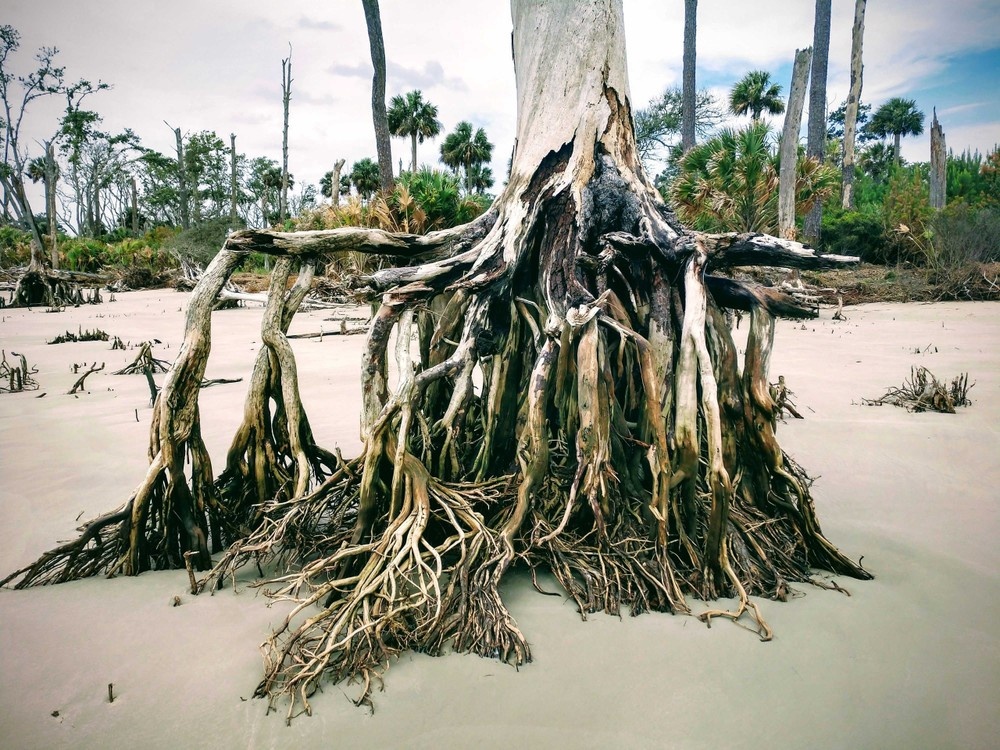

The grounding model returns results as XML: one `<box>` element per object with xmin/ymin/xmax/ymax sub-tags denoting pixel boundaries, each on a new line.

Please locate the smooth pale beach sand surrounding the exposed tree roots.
<box><xmin>0</xmin><ymin>292</ymin><xmax>1000</xmax><ymax>750</ymax></box>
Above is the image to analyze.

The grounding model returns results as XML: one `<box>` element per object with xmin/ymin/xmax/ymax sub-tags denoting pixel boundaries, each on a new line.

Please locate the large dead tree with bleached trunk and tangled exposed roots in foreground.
<box><xmin>0</xmin><ymin>0</ymin><xmax>870</xmax><ymax>717</ymax></box>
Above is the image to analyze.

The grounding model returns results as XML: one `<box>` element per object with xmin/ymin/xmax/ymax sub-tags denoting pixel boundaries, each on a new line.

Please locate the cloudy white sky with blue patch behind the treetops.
<box><xmin>7</xmin><ymin>0</ymin><xmax>1000</xmax><ymax>206</ymax></box>
